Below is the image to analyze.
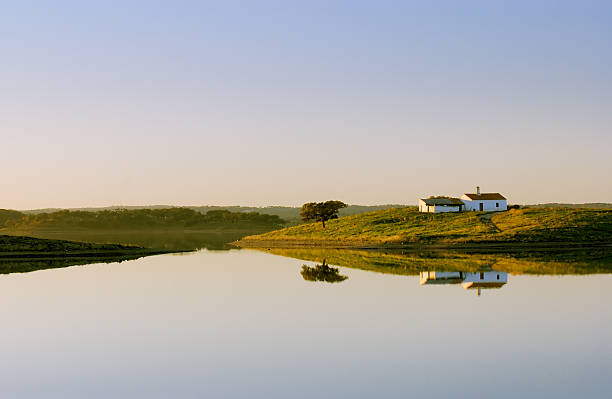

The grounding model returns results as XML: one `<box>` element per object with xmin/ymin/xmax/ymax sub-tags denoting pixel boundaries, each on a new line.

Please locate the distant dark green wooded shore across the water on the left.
<box><xmin>0</xmin><ymin>208</ymin><xmax>287</xmax><ymax>230</ymax></box>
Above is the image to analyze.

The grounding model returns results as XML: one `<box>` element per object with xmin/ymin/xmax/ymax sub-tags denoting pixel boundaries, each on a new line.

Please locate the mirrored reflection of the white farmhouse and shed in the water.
<box><xmin>419</xmin><ymin>270</ymin><xmax>508</xmax><ymax>295</ymax></box>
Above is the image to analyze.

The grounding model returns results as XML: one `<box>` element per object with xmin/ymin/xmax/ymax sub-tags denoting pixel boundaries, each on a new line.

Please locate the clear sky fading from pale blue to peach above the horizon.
<box><xmin>0</xmin><ymin>0</ymin><xmax>612</xmax><ymax>209</ymax></box>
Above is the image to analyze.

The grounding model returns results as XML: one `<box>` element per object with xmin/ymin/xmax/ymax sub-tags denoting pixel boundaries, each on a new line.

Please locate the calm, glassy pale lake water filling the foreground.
<box><xmin>0</xmin><ymin>250</ymin><xmax>612</xmax><ymax>398</ymax></box>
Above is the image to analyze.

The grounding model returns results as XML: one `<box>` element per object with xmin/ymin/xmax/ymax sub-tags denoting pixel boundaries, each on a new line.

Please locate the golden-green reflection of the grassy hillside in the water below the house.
<box><xmin>265</xmin><ymin>248</ymin><xmax>612</xmax><ymax>275</ymax></box>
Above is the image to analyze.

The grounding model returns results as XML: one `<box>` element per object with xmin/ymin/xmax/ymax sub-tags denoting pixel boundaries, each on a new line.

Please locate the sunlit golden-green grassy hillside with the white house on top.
<box><xmin>239</xmin><ymin>207</ymin><xmax>612</xmax><ymax>246</ymax></box>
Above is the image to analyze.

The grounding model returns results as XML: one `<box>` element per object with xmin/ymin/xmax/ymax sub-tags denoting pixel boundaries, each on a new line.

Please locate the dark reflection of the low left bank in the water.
<box><xmin>0</xmin><ymin>255</ymin><xmax>147</xmax><ymax>274</ymax></box>
